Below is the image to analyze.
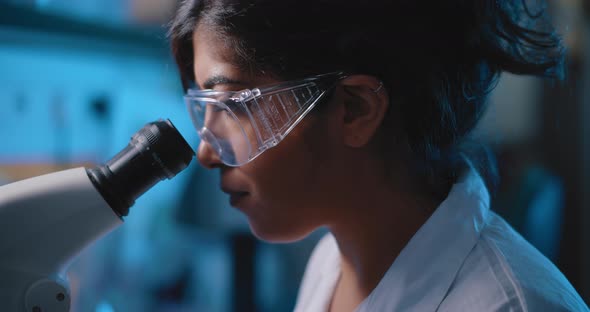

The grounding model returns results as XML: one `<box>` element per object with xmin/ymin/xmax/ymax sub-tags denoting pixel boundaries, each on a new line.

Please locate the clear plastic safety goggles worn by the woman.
<box><xmin>185</xmin><ymin>72</ymin><xmax>345</xmax><ymax>167</ymax></box>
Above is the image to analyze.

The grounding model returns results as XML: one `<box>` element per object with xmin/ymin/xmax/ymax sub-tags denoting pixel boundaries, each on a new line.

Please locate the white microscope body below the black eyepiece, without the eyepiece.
<box><xmin>0</xmin><ymin>168</ymin><xmax>123</xmax><ymax>312</ymax></box>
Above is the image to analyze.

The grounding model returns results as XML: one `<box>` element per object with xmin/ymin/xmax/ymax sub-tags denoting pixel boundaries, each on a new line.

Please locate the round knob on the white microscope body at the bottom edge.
<box><xmin>25</xmin><ymin>279</ymin><xmax>70</xmax><ymax>312</ymax></box>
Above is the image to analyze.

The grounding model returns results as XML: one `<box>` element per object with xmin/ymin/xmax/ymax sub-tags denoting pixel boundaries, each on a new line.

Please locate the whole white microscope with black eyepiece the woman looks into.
<box><xmin>0</xmin><ymin>120</ymin><xmax>195</xmax><ymax>312</ymax></box>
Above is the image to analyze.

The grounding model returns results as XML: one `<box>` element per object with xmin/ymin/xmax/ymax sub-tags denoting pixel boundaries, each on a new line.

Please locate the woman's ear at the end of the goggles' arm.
<box><xmin>341</xmin><ymin>75</ymin><xmax>389</xmax><ymax>148</ymax></box>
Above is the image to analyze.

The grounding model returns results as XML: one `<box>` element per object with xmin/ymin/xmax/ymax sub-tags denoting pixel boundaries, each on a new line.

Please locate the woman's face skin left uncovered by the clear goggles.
<box><xmin>193</xmin><ymin>26</ymin><xmax>342</xmax><ymax>241</ymax></box>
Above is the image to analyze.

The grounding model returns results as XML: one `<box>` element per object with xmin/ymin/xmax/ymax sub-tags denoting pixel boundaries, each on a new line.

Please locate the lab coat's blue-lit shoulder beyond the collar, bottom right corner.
<box><xmin>438</xmin><ymin>213</ymin><xmax>589</xmax><ymax>311</ymax></box>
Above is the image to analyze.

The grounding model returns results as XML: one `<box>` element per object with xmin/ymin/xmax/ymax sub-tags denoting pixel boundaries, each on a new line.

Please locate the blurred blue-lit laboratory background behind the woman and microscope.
<box><xmin>0</xmin><ymin>0</ymin><xmax>590</xmax><ymax>312</ymax></box>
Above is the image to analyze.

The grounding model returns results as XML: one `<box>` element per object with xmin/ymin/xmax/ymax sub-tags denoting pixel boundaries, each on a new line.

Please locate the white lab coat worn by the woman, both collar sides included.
<box><xmin>295</xmin><ymin>169</ymin><xmax>589</xmax><ymax>312</ymax></box>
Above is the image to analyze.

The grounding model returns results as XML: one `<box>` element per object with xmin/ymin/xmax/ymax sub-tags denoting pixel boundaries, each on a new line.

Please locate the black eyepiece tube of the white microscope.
<box><xmin>87</xmin><ymin>119</ymin><xmax>195</xmax><ymax>217</ymax></box>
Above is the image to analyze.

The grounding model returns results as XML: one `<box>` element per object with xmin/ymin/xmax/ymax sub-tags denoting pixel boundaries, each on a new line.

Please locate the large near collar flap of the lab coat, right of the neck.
<box><xmin>357</xmin><ymin>168</ymin><xmax>490</xmax><ymax>312</ymax></box>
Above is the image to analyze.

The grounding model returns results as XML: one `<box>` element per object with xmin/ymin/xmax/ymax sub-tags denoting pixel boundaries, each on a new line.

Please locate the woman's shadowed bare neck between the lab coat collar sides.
<box><xmin>329</xmin><ymin>166</ymin><xmax>440</xmax><ymax>311</ymax></box>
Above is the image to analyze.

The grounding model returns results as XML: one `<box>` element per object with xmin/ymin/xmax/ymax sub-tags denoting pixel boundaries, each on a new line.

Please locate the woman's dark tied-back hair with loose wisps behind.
<box><xmin>169</xmin><ymin>0</ymin><xmax>565</xmax><ymax>196</ymax></box>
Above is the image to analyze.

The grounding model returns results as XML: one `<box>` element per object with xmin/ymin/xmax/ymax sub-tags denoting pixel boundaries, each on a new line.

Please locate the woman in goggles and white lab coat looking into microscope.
<box><xmin>170</xmin><ymin>0</ymin><xmax>587</xmax><ymax>311</ymax></box>
